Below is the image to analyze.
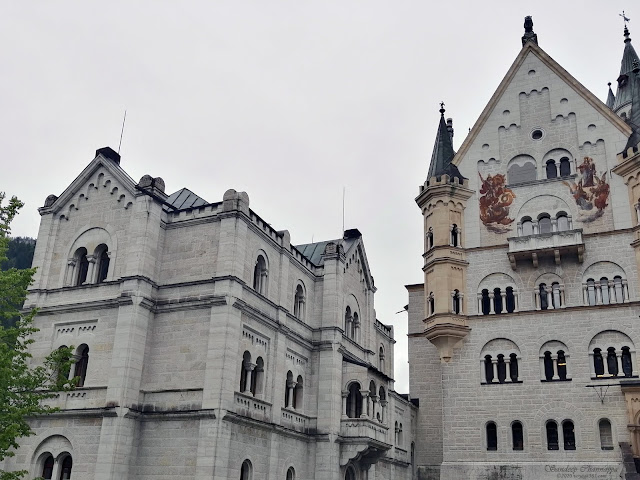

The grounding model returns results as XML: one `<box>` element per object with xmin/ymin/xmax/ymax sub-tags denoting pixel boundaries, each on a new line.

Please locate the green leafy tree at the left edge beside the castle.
<box><xmin>0</xmin><ymin>192</ymin><xmax>77</xmax><ymax>480</ymax></box>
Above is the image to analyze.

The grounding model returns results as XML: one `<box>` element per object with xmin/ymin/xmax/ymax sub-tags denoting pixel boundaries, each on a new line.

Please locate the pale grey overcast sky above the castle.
<box><xmin>0</xmin><ymin>0</ymin><xmax>640</xmax><ymax>392</ymax></box>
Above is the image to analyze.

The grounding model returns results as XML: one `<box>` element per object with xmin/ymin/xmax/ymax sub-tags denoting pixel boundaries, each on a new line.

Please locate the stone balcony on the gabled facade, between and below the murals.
<box><xmin>508</xmin><ymin>229</ymin><xmax>584</xmax><ymax>270</ymax></box>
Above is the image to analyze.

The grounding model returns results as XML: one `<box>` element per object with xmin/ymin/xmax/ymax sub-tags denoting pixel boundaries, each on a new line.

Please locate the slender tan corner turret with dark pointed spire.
<box><xmin>416</xmin><ymin>104</ymin><xmax>473</xmax><ymax>362</ymax></box>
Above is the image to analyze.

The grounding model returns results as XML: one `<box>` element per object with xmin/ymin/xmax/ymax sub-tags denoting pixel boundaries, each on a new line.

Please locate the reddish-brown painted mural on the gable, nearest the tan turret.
<box><xmin>478</xmin><ymin>172</ymin><xmax>516</xmax><ymax>233</ymax></box>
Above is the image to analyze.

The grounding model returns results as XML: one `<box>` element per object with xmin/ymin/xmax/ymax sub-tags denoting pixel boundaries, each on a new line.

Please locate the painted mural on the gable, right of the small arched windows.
<box><xmin>562</xmin><ymin>157</ymin><xmax>609</xmax><ymax>223</ymax></box>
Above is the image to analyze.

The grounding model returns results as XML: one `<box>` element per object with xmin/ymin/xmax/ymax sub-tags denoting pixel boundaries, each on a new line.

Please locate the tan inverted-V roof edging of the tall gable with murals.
<box><xmin>453</xmin><ymin>42</ymin><xmax>632</xmax><ymax>164</ymax></box>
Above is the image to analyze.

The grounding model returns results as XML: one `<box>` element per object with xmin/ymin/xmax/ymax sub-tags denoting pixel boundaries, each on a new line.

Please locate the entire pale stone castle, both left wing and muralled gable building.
<box><xmin>3</xmin><ymin>18</ymin><xmax>640</xmax><ymax>480</ymax></box>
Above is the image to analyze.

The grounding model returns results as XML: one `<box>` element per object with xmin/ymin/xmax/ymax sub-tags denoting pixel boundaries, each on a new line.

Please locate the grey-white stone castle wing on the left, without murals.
<box><xmin>3</xmin><ymin>149</ymin><xmax>417</xmax><ymax>480</ymax></box>
